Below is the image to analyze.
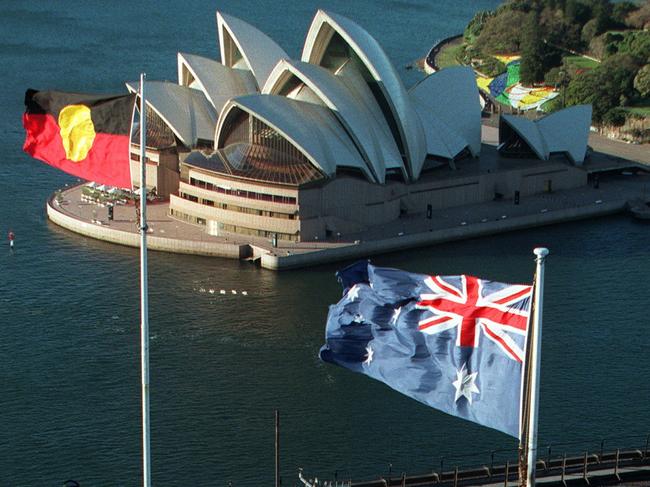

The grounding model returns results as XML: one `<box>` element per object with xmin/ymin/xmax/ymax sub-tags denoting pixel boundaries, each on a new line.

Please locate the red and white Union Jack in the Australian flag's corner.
<box><xmin>417</xmin><ymin>275</ymin><xmax>532</xmax><ymax>362</ymax></box>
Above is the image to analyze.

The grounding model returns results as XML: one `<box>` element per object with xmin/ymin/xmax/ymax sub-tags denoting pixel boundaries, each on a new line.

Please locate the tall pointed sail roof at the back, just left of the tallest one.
<box><xmin>217</xmin><ymin>12</ymin><xmax>289</xmax><ymax>88</ymax></box>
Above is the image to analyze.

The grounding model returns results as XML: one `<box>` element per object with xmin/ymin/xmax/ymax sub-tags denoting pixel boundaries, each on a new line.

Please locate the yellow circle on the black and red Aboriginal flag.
<box><xmin>59</xmin><ymin>105</ymin><xmax>96</xmax><ymax>162</ymax></box>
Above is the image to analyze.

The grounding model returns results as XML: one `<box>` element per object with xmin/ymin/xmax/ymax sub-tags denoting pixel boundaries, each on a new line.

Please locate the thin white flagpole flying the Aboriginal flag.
<box><xmin>140</xmin><ymin>73</ymin><xmax>151</xmax><ymax>487</ymax></box>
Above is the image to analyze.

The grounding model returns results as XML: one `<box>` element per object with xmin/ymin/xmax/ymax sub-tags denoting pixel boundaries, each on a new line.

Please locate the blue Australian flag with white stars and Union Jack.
<box><xmin>320</xmin><ymin>262</ymin><xmax>532</xmax><ymax>438</ymax></box>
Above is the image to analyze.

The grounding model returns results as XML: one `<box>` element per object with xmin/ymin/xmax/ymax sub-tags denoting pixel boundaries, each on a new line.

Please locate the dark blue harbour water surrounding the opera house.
<box><xmin>0</xmin><ymin>0</ymin><xmax>650</xmax><ymax>487</ymax></box>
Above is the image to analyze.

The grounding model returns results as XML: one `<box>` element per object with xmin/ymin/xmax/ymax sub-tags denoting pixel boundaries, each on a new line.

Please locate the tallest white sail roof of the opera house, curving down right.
<box><xmin>302</xmin><ymin>10</ymin><xmax>426</xmax><ymax>179</ymax></box>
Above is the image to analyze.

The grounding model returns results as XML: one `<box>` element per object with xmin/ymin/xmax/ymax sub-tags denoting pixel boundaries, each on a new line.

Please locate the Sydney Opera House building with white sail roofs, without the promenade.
<box><xmin>127</xmin><ymin>11</ymin><xmax>590</xmax><ymax>241</ymax></box>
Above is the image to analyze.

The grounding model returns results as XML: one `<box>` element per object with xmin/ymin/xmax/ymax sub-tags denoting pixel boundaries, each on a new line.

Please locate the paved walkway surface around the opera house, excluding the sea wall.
<box><xmin>55</xmin><ymin>126</ymin><xmax>650</xmax><ymax>262</ymax></box>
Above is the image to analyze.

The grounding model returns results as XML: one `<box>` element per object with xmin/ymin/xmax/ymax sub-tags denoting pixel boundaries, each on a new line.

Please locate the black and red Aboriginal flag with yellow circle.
<box><xmin>23</xmin><ymin>90</ymin><xmax>136</xmax><ymax>188</ymax></box>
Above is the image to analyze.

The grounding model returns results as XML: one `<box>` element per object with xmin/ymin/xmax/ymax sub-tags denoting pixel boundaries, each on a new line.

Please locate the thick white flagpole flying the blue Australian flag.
<box><xmin>526</xmin><ymin>247</ymin><xmax>549</xmax><ymax>487</ymax></box>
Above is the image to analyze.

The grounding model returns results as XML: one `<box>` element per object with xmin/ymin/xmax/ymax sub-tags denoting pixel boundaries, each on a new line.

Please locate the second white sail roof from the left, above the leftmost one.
<box><xmin>178</xmin><ymin>52</ymin><xmax>257</xmax><ymax>112</ymax></box>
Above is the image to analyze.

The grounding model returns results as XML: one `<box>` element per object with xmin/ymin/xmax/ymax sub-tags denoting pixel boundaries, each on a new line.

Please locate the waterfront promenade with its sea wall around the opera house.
<box><xmin>47</xmin><ymin>126</ymin><xmax>650</xmax><ymax>270</ymax></box>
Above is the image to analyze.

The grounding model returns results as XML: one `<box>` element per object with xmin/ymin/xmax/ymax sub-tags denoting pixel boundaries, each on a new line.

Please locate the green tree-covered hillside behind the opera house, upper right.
<box><xmin>456</xmin><ymin>0</ymin><xmax>650</xmax><ymax>125</ymax></box>
